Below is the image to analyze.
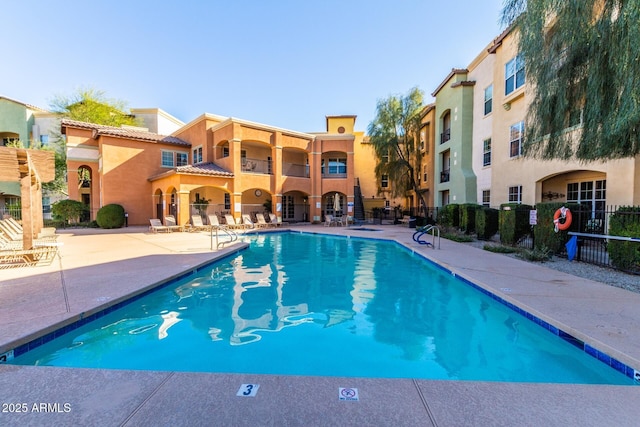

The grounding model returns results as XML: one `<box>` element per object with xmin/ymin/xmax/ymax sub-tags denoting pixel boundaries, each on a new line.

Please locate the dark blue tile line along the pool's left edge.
<box><xmin>7</xmin><ymin>249</ymin><xmax>248</xmax><ymax>363</ymax></box>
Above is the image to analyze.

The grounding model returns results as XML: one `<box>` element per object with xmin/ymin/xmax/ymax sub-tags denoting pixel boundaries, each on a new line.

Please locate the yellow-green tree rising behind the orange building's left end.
<box><xmin>43</xmin><ymin>88</ymin><xmax>138</xmax><ymax>193</ymax></box>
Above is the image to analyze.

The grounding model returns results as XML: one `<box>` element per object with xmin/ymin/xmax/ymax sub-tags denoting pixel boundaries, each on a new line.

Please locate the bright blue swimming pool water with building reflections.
<box><xmin>12</xmin><ymin>233</ymin><xmax>633</xmax><ymax>384</ymax></box>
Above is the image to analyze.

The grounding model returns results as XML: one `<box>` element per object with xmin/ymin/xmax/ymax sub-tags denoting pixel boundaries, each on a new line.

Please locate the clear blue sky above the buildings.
<box><xmin>0</xmin><ymin>0</ymin><xmax>503</xmax><ymax>132</ymax></box>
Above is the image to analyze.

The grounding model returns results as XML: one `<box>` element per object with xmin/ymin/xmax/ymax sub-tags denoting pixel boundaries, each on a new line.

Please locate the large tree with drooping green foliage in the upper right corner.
<box><xmin>502</xmin><ymin>0</ymin><xmax>640</xmax><ymax>161</ymax></box>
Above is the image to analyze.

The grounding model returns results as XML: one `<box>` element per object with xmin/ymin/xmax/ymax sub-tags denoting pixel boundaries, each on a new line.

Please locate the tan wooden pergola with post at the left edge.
<box><xmin>0</xmin><ymin>147</ymin><xmax>55</xmax><ymax>249</ymax></box>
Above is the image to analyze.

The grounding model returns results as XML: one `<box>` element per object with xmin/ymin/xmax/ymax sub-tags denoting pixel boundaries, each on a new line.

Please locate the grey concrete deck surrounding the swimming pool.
<box><xmin>0</xmin><ymin>226</ymin><xmax>640</xmax><ymax>426</ymax></box>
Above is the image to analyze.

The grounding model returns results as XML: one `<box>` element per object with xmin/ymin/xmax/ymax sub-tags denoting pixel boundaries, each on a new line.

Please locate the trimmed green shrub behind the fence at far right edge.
<box><xmin>607</xmin><ymin>206</ymin><xmax>640</xmax><ymax>270</ymax></box>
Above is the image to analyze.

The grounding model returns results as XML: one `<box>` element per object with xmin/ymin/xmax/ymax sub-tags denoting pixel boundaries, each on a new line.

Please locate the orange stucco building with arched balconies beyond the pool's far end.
<box><xmin>61</xmin><ymin>112</ymin><xmax>373</xmax><ymax>224</ymax></box>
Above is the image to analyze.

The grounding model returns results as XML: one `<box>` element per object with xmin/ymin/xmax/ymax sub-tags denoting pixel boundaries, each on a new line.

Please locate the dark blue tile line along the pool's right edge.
<box><xmin>408</xmin><ymin>243</ymin><xmax>637</xmax><ymax>380</ymax></box>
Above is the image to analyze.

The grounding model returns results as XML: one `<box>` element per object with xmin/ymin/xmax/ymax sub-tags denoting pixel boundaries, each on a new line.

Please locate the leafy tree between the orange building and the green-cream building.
<box><xmin>367</xmin><ymin>88</ymin><xmax>427</xmax><ymax>217</ymax></box>
